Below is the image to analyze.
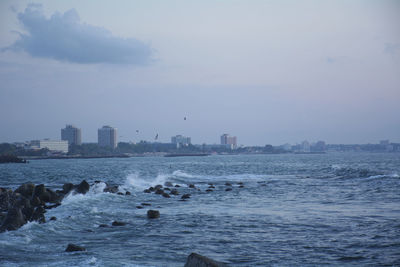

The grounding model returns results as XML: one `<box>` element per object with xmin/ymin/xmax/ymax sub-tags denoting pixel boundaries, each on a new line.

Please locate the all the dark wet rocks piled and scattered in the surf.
<box><xmin>0</xmin><ymin>180</ymin><xmax>238</xmax><ymax>267</ymax></box>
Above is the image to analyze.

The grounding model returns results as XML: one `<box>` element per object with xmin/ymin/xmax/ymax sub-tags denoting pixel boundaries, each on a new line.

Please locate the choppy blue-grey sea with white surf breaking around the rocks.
<box><xmin>0</xmin><ymin>153</ymin><xmax>400</xmax><ymax>266</ymax></box>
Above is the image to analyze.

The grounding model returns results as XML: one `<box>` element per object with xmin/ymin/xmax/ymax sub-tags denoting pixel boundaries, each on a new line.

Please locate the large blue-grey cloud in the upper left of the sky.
<box><xmin>3</xmin><ymin>4</ymin><xmax>152</xmax><ymax>65</ymax></box>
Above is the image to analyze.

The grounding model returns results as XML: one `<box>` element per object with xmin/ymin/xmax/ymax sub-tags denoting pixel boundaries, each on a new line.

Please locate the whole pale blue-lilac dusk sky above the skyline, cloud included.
<box><xmin>0</xmin><ymin>0</ymin><xmax>400</xmax><ymax>145</ymax></box>
